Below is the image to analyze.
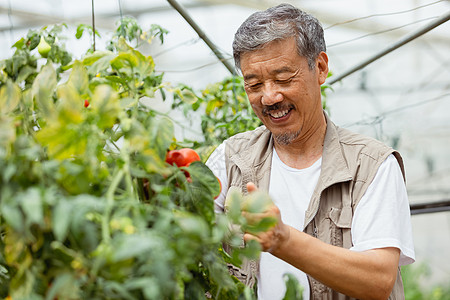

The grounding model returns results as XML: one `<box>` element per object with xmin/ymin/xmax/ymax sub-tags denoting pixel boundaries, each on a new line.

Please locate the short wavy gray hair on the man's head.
<box><xmin>233</xmin><ymin>4</ymin><xmax>326</xmax><ymax>70</ymax></box>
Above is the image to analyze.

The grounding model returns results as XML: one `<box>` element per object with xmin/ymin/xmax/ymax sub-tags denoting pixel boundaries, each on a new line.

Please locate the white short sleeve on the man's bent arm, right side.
<box><xmin>350</xmin><ymin>154</ymin><xmax>415</xmax><ymax>266</ymax></box>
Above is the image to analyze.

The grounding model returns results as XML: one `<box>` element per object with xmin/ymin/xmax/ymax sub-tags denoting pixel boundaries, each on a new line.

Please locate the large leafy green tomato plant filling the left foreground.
<box><xmin>0</xmin><ymin>19</ymin><xmax>268</xmax><ymax>299</ymax></box>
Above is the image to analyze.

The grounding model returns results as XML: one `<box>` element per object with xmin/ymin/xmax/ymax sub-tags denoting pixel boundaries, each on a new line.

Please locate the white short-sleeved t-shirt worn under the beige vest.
<box><xmin>206</xmin><ymin>144</ymin><xmax>415</xmax><ymax>300</ymax></box>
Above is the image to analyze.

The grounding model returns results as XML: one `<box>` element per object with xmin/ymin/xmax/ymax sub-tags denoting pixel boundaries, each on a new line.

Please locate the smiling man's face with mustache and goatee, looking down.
<box><xmin>241</xmin><ymin>38</ymin><xmax>328</xmax><ymax>145</ymax></box>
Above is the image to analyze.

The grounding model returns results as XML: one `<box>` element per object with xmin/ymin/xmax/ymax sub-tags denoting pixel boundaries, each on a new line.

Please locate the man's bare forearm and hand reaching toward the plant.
<box><xmin>244</xmin><ymin>184</ymin><xmax>400</xmax><ymax>299</ymax></box>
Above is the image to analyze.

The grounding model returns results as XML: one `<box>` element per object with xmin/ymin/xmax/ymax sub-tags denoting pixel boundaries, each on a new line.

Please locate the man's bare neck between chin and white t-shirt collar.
<box><xmin>274</xmin><ymin>113</ymin><xmax>327</xmax><ymax>169</ymax></box>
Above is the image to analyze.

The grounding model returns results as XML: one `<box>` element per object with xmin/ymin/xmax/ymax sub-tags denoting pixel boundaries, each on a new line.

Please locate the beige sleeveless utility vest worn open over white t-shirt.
<box><xmin>224</xmin><ymin>114</ymin><xmax>405</xmax><ymax>299</ymax></box>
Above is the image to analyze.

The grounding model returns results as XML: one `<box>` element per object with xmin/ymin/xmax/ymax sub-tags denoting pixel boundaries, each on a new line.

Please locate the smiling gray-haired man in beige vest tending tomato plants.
<box><xmin>207</xmin><ymin>4</ymin><xmax>414</xmax><ymax>300</ymax></box>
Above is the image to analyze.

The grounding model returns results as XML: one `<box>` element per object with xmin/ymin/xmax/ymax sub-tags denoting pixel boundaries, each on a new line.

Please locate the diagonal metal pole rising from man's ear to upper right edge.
<box><xmin>328</xmin><ymin>12</ymin><xmax>450</xmax><ymax>85</ymax></box>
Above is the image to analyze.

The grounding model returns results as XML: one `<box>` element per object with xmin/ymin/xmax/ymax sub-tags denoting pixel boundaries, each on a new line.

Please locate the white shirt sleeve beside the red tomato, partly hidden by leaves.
<box><xmin>206</xmin><ymin>143</ymin><xmax>228</xmax><ymax>213</ymax></box>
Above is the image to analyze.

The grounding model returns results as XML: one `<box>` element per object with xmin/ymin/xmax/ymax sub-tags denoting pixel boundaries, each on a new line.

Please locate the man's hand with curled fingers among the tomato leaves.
<box><xmin>242</xmin><ymin>182</ymin><xmax>290</xmax><ymax>252</ymax></box>
